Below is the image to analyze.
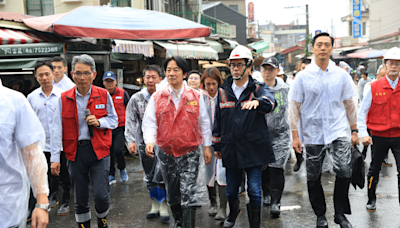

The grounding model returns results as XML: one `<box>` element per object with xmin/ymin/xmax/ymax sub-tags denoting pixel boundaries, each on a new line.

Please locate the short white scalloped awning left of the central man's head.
<box><xmin>112</xmin><ymin>40</ymin><xmax>154</xmax><ymax>58</ymax></box>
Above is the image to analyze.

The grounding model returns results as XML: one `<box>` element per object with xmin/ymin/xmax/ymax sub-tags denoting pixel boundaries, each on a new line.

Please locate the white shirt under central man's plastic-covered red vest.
<box><xmin>142</xmin><ymin>83</ymin><xmax>211</xmax><ymax>146</ymax></box>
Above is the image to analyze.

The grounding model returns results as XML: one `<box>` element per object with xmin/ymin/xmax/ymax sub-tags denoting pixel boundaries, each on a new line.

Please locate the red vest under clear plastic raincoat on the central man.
<box><xmin>153</xmin><ymin>86</ymin><xmax>202</xmax><ymax>157</ymax></box>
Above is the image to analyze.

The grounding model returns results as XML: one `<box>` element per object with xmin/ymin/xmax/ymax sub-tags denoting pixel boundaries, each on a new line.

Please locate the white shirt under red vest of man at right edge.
<box><xmin>357</xmin><ymin>76</ymin><xmax>399</xmax><ymax>138</ymax></box>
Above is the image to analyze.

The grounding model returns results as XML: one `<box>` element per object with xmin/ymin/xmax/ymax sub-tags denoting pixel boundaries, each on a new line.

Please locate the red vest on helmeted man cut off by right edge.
<box><xmin>367</xmin><ymin>77</ymin><xmax>400</xmax><ymax>138</ymax></box>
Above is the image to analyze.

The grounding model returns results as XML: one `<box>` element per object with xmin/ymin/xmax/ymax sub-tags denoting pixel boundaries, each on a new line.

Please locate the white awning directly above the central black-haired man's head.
<box><xmin>154</xmin><ymin>41</ymin><xmax>218</xmax><ymax>60</ymax></box>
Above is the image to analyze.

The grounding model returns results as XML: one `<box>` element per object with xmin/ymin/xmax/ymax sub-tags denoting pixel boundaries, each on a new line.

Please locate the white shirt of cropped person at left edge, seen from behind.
<box><xmin>0</xmin><ymin>80</ymin><xmax>45</xmax><ymax>227</ymax></box>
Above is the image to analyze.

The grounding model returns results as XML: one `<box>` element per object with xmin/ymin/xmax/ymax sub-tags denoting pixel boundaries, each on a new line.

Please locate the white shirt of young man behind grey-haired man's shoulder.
<box><xmin>28</xmin><ymin>86</ymin><xmax>63</xmax><ymax>152</ymax></box>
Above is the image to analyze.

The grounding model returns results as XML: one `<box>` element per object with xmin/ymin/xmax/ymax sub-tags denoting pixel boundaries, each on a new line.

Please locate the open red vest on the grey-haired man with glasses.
<box><xmin>61</xmin><ymin>85</ymin><xmax>112</xmax><ymax>161</ymax></box>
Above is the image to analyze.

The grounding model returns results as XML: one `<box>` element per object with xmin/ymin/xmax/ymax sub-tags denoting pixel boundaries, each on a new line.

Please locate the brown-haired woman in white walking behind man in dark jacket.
<box><xmin>200</xmin><ymin>67</ymin><xmax>227</xmax><ymax>221</ymax></box>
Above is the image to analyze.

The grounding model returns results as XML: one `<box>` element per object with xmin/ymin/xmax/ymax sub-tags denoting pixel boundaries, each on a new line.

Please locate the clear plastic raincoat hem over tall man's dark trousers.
<box><xmin>305</xmin><ymin>137</ymin><xmax>352</xmax><ymax>181</ymax></box>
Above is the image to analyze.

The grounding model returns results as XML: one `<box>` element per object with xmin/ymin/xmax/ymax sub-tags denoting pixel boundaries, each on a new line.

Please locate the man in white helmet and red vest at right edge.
<box><xmin>358</xmin><ymin>47</ymin><xmax>400</xmax><ymax>211</ymax></box>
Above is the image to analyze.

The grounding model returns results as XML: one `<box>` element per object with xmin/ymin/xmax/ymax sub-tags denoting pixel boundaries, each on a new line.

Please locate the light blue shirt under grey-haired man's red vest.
<box><xmin>50</xmin><ymin>86</ymin><xmax>118</xmax><ymax>162</ymax></box>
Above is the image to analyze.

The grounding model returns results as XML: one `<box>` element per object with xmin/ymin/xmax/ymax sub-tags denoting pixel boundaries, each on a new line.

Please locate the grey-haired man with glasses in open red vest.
<box><xmin>51</xmin><ymin>55</ymin><xmax>118</xmax><ymax>228</ymax></box>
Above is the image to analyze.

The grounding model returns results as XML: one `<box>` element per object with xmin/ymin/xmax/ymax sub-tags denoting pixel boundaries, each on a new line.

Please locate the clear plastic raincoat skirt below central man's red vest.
<box><xmin>158</xmin><ymin>147</ymin><xmax>208</xmax><ymax>207</ymax></box>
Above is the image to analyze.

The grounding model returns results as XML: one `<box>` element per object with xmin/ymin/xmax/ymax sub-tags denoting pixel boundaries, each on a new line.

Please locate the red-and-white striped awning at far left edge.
<box><xmin>0</xmin><ymin>29</ymin><xmax>66</xmax><ymax>45</ymax></box>
